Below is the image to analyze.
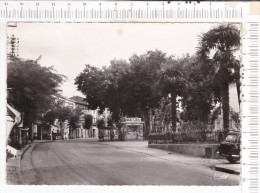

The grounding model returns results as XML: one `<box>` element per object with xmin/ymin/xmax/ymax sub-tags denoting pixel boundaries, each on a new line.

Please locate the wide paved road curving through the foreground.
<box><xmin>21</xmin><ymin>140</ymin><xmax>239</xmax><ymax>185</ymax></box>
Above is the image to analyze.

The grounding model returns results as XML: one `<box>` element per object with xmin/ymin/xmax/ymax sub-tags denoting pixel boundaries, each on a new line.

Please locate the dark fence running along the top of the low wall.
<box><xmin>148</xmin><ymin>131</ymin><xmax>225</xmax><ymax>144</ymax></box>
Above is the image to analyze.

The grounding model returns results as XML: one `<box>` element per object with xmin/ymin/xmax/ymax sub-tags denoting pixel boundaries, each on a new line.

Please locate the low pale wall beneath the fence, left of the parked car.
<box><xmin>148</xmin><ymin>144</ymin><xmax>219</xmax><ymax>158</ymax></box>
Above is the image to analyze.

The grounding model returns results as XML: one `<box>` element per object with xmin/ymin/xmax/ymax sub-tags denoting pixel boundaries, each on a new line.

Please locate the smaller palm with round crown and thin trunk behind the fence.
<box><xmin>156</xmin><ymin>68</ymin><xmax>186</xmax><ymax>132</ymax></box>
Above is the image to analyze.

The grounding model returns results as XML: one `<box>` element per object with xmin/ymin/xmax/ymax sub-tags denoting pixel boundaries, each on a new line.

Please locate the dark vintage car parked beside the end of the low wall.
<box><xmin>218</xmin><ymin>131</ymin><xmax>241</xmax><ymax>163</ymax></box>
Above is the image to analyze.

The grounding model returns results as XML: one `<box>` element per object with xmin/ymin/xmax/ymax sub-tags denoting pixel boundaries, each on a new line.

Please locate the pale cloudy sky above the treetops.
<box><xmin>7</xmin><ymin>23</ymin><xmax>222</xmax><ymax>98</ymax></box>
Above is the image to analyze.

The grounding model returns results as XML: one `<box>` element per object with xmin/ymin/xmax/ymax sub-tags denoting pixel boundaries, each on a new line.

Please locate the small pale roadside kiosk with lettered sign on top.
<box><xmin>121</xmin><ymin>117</ymin><xmax>144</xmax><ymax>140</ymax></box>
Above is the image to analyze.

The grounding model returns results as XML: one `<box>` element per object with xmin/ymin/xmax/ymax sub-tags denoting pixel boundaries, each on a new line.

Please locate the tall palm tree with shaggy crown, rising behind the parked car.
<box><xmin>197</xmin><ymin>24</ymin><xmax>240</xmax><ymax>132</ymax></box>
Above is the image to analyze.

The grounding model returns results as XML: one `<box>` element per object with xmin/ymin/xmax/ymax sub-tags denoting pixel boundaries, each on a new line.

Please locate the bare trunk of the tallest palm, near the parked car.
<box><xmin>221</xmin><ymin>82</ymin><xmax>229</xmax><ymax>133</ymax></box>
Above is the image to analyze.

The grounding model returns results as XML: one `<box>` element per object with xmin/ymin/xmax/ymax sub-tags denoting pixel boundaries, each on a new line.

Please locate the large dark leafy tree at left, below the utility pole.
<box><xmin>7</xmin><ymin>57</ymin><xmax>65</xmax><ymax>139</ymax></box>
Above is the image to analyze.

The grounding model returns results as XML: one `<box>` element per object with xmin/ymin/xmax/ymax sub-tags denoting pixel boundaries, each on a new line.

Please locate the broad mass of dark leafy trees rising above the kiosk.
<box><xmin>75</xmin><ymin>50</ymin><xmax>166</xmax><ymax>133</ymax></box>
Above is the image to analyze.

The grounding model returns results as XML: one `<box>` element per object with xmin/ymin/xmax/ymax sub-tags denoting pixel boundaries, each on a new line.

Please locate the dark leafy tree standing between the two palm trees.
<box><xmin>181</xmin><ymin>56</ymin><xmax>214</xmax><ymax>123</ymax></box>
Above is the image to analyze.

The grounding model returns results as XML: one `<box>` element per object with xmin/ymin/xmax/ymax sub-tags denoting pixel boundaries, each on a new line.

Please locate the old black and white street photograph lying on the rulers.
<box><xmin>6</xmin><ymin>22</ymin><xmax>242</xmax><ymax>186</ymax></box>
